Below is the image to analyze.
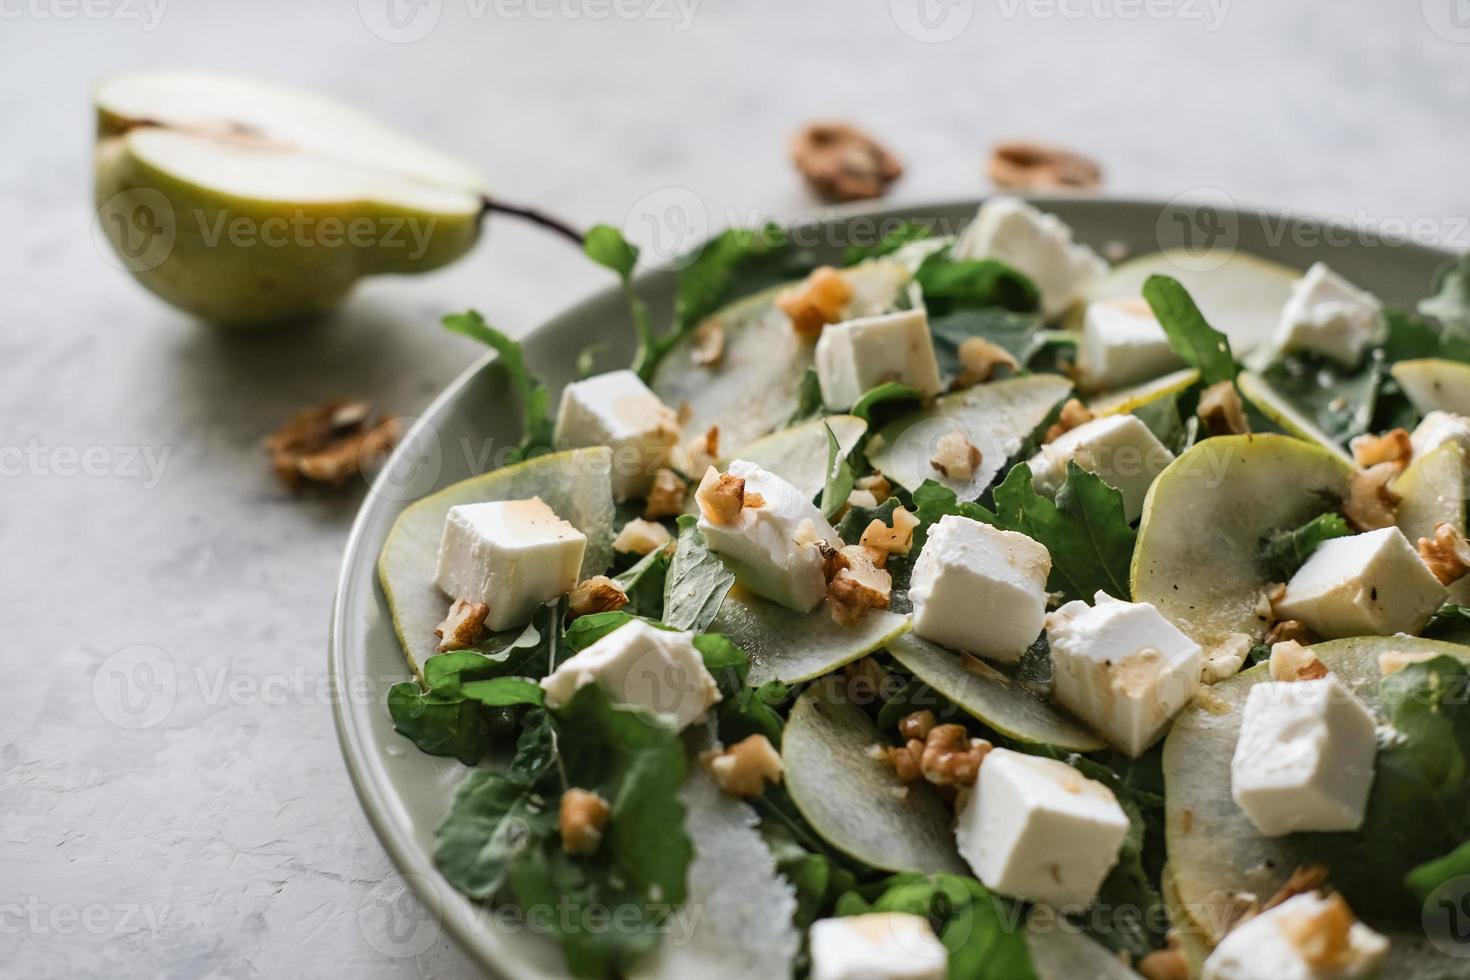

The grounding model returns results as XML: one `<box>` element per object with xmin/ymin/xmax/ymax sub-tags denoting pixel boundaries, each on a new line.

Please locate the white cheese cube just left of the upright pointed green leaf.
<box><xmin>1078</xmin><ymin>300</ymin><xmax>1183</xmax><ymax>391</ymax></box>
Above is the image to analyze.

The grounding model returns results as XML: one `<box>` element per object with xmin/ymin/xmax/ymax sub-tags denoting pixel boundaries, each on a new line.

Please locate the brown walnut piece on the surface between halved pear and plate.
<box><xmin>265</xmin><ymin>401</ymin><xmax>398</xmax><ymax>489</ymax></box>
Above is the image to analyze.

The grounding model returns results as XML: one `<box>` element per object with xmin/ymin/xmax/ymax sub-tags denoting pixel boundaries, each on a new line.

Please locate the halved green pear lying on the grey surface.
<box><xmin>96</xmin><ymin>71</ymin><xmax>487</xmax><ymax>326</ymax></box>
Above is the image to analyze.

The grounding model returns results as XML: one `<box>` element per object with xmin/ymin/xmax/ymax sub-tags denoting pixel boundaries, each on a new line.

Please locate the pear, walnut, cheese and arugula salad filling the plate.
<box><xmin>379</xmin><ymin>197</ymin><xmax>1470</xmax><ymax>980</ymax></box>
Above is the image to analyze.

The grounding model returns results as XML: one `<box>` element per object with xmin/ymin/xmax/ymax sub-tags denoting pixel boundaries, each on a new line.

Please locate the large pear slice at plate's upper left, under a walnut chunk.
<box><xmin>653</xmin><ymin>259</ymin><xmax>910</xmax><ymax>449</ymax></box>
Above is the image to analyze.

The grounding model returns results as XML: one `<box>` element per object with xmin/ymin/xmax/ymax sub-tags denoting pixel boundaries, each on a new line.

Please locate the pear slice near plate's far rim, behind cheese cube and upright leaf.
<box><xmin>1086</xmin><ymin>248</ymin><xmax>1301</xmax><ymax>357</ymax></box>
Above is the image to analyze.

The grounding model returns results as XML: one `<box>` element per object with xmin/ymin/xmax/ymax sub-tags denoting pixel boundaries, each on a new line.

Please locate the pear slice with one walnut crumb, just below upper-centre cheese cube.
<box><xmin>867</xmin><ymin>375</ymin><xmax>1072</xmax><ymax>500</ymax></box>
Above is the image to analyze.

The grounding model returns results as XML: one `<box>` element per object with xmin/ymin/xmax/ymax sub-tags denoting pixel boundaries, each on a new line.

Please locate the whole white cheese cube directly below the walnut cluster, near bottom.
<box><xmin>954</xmin><ymin>749</ymin><xmax>1127</xmax><ymax>911</ymax></box>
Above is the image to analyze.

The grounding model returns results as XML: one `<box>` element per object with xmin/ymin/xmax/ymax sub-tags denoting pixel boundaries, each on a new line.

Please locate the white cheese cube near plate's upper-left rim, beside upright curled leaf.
<box><xmin>553</xmin><ymin>370</ymin><xmax>679</xmax><ymax>501</ymax></box>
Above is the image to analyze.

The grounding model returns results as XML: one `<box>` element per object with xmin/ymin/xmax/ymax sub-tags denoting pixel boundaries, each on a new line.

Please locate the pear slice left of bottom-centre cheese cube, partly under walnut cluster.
<box><xmin>781</xmin><ymin>677</ymin><xmax>970</xmax><ymax>874</ymax></box>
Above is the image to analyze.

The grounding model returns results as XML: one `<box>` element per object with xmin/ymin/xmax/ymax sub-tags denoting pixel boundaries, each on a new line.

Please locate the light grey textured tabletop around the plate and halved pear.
<box><xmin>0</xmin><ymin>0</ymin><xmax>1470</xmax><ymax>977</ymax></box>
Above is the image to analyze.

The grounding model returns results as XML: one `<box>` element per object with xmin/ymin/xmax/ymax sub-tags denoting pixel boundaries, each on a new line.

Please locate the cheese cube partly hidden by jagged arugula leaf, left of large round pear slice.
<box><xmin>1028</xmin><ymin>414</ymin><xmax>1175</xmax><ymax>522</ymax></box>
